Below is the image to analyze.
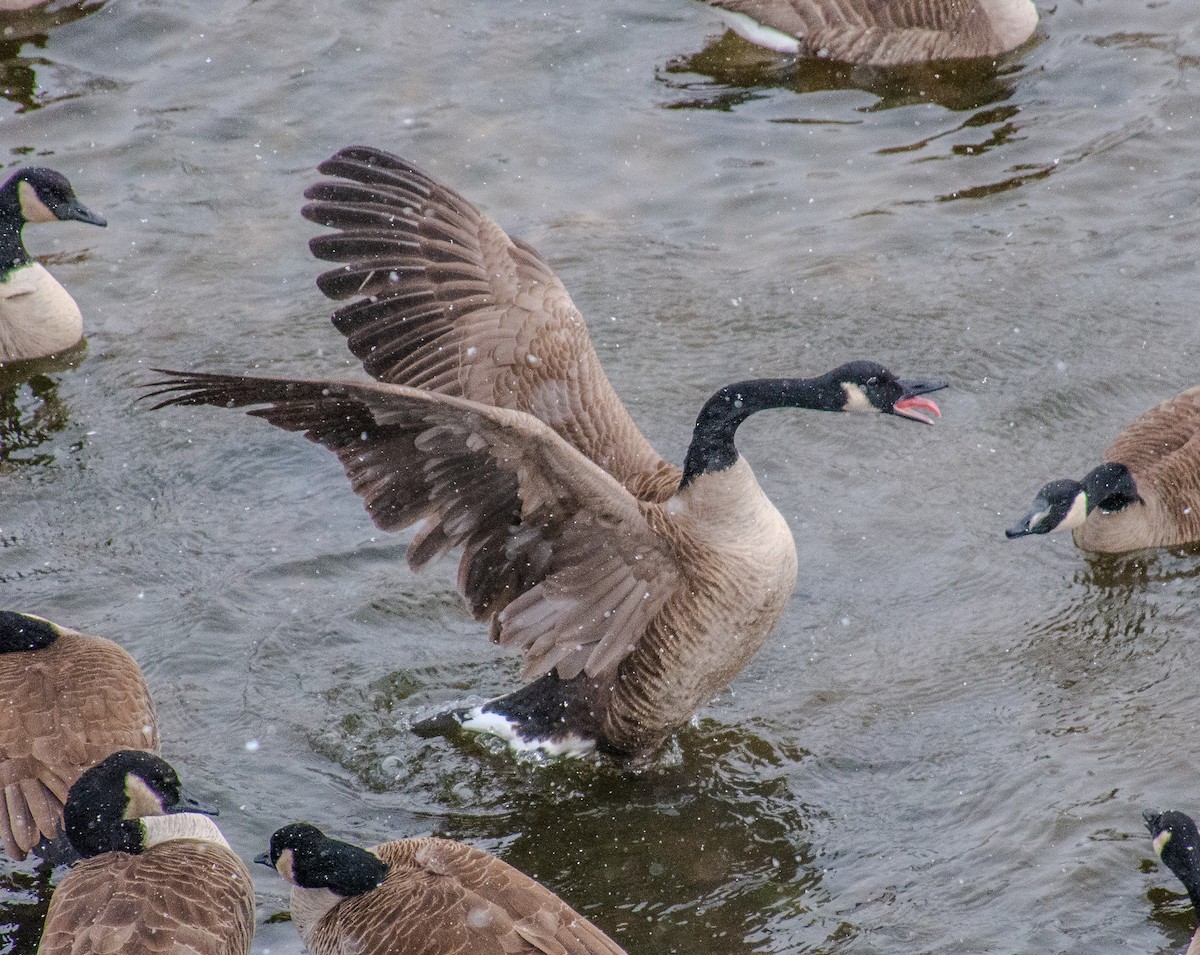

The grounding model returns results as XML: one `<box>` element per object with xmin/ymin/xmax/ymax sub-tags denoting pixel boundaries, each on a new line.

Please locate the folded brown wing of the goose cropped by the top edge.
<box><xmin>712</xmin><ymin>0</ymin><xmax>1003</xmax><ymax>66</ymax></box>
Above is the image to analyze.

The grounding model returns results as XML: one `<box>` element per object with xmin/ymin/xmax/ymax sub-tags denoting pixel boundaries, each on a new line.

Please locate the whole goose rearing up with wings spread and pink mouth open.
<box><xmin>145</xmin><ymin>146</ymin><xmax>944</xmax><ymax>757</ymax></box>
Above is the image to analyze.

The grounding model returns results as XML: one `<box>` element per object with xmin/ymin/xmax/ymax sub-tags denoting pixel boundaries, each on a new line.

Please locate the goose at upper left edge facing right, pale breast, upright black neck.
<box><xmin>0</xmin><ymin>167</ymin><xmax>108</xmax><ymax>364</ymax></box>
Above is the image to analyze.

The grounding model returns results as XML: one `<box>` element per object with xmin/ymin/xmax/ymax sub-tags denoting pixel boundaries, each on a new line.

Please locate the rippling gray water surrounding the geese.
<box><xmin>0</xmin><ymin>0</ymin><xmax>1200</xmax><ymax>955</ymax></box>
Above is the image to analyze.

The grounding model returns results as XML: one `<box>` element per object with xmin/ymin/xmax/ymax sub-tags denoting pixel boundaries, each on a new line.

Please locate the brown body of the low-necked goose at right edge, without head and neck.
<box><xmin>1074</xmin><ymin>386</ymin><xmax>1200</xmax><ymax>552</ymax></box>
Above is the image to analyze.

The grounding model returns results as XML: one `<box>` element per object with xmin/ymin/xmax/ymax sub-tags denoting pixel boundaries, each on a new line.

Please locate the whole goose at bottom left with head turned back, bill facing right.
<box><xmin>37</xmin><ymin>750</ymin><xmax>254</xmax><ymax>955</ymax></box>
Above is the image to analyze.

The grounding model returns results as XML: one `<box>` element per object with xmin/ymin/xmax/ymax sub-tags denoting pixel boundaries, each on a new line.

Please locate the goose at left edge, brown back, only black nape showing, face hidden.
<box><xmin>0</xmin><ymin>611</ymin><xmax>158</xmax><ymax>859</ymax></box>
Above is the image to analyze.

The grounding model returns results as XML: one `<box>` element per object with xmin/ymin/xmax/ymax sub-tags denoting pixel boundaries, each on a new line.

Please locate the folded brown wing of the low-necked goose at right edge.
<box><xmin>1104</xmin><ymin>386</ymin><xmax>1200</xmax><ymax>503</ymax></box>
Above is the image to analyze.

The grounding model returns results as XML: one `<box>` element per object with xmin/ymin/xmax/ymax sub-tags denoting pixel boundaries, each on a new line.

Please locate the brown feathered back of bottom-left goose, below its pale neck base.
<box><xmin>38</xmin><ymin>840</ymin><xmax>254</xmax><ymax>955</ymax></box>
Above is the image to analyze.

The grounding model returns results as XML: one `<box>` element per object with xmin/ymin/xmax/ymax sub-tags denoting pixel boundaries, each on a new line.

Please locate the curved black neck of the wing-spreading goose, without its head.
<box><xmin>679</xmin><ymin>374</ymin><xmax>846</xmax><ymax>489</ymax></box>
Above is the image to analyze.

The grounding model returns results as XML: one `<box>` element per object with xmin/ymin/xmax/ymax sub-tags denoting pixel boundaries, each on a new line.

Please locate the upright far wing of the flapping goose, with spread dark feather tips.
<box><xmin>302</xmin><ymin>146</ymin><xmax>680</xmax><ymax>499</ymax></box>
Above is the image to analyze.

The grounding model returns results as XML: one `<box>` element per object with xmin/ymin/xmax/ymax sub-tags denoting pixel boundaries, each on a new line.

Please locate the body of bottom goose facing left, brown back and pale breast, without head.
<box><xmin>292</xmin><ymin>839</ymin><xmax>624</xmax><ymax>955</ymax></box>
